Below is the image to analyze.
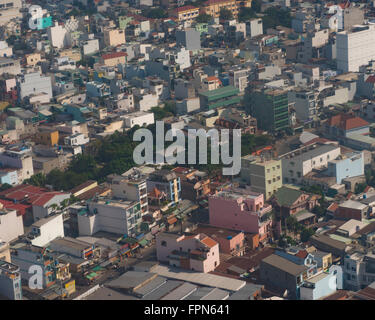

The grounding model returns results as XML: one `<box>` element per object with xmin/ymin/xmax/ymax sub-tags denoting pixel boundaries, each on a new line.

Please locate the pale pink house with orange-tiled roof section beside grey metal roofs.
<box><xmin>156</xmin><ymin>232</ymin><xmax>220</xmax><ymax>273</ymax></box>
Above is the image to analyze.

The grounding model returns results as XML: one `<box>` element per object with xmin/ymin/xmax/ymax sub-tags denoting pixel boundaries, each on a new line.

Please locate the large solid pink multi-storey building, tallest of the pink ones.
<box><xmin>208</xmin><ymin>189</ymin><xmax>272</xmax><ymax>241</ymax></box>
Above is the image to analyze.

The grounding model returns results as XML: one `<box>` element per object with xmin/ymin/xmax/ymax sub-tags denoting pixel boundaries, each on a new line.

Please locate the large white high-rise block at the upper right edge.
<box><xmin>336</xmin><ymin>24</ymin><xmax>375</xmax><ymax>72</ymax></box>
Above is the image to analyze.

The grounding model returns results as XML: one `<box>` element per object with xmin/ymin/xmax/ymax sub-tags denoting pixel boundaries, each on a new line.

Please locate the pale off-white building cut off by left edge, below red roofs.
<box><xmin>0</xmin><ymin>204</ymin><xmax>24</xmax><ymax>242</ymax></box>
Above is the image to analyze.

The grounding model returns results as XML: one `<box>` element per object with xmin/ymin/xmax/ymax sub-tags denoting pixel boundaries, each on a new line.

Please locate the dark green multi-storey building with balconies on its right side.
<box><xmin>248</xmin><ymin>89</ymin><xmax>290</xmax><ymax>132</ymax></box>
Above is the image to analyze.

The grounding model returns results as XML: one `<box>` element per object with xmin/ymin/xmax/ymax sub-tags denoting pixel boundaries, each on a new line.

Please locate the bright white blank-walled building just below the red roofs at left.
<box><xmin>28</xmin><ymin>214</ymin><xmax>65</xmax><ymax>247</ymax></box>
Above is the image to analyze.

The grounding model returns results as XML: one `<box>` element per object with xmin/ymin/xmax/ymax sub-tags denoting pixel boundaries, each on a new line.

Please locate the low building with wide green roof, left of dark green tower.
<box><xmin>199</xmin><ymin>86</ymin><xmax>242</xmax><ymax>110</ymax></box>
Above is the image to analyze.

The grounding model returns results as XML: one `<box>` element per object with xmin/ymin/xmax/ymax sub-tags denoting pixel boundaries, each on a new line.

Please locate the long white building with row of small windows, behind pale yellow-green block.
<box><xmin>280</xmin><ymin>144</ymin><xmax>341</xmax><ymax>184</ymax></box>
